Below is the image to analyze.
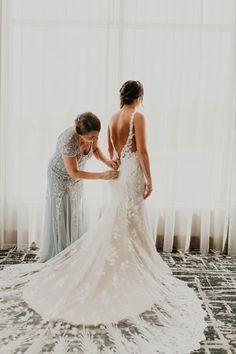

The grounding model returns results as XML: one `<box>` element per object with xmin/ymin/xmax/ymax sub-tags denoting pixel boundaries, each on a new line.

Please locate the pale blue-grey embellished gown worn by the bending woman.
<box><xmin>39</xmin><ymin>127</ymin><xmax>93</xmax><ymax>262</ymax></box>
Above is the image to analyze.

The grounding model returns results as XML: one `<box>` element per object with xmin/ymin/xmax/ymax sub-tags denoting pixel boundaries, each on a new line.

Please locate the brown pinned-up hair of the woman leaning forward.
<box><xmin>75</xmin><ymin>112</ymin><xmax>101</xmax><ymax>135</ymax></box>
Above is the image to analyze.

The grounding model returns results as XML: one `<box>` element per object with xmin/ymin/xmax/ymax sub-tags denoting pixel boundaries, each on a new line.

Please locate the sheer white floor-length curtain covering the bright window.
<box><xmin>0</xmin><ymin>0</ymin><xmax>236</xmax><ymax>254</ymax></box>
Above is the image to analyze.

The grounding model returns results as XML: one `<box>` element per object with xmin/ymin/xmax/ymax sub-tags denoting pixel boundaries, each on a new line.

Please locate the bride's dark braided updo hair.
<box><xmin>120</xmin><ymin>80</ymin><xmax>143</xmax><ymax>108</ymax></box>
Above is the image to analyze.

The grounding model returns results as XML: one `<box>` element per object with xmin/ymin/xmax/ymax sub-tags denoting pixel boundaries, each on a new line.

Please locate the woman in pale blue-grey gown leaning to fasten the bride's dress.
<box><xmin>39</xmin><ymin>112</ymin><xmax>118</xmax><ymax>262</ymax></box>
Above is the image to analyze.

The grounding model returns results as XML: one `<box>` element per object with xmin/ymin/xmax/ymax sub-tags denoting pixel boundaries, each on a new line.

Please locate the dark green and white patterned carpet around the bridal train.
<box><xmin>0</xmin><ymin>249</ymin><xmax>236</xmax><ymax>354</ymax></box>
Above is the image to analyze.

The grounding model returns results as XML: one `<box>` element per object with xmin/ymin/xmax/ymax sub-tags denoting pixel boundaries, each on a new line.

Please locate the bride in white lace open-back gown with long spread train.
<box><xmin>0</xmin><ymin>81</ymin><xmax>206</xmax><ymax>354</ymax></box>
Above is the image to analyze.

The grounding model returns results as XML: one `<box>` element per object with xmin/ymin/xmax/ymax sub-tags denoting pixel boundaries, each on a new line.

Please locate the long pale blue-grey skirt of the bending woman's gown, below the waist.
<box><xmin>39</xmin><ymin>164</ymin><xmax>87</xmax><ymax>262</ymax></box>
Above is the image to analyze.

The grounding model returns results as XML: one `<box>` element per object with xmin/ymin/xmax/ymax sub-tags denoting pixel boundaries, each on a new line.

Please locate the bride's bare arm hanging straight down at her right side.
<box><xmin>134</xmin><ymin>112</ymin><xmax>152</xmax><ymax>198</ymax></box>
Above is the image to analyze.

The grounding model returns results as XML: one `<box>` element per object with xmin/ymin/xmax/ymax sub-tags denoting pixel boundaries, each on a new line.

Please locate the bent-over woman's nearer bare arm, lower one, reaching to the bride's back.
<box><xmin>63</xmin><ymin>156</ymin><xmax>119</xmax><ymax>179</ymax></box>
